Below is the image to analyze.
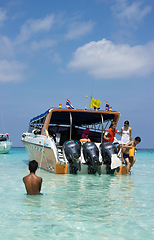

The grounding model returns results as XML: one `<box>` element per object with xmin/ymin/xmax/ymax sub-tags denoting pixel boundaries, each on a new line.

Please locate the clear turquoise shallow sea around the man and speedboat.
<box><xmin>0</xmin><ymin>148</ymin><xmax>154</xmax><ymax>240</ymax></box>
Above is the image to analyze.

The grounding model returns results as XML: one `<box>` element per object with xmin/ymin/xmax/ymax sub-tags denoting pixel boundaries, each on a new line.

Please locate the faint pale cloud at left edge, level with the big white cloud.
<box><xmin>0</xmin><ymin>60</ymin><xmax>27</xmax><ymax>82</ymax></box>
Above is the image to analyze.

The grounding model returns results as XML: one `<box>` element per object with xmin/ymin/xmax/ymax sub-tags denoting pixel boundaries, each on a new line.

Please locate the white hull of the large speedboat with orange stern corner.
<box><xmin>22</xmin><ymin>134</ymin><xmax>120</xmax><ymax>174</ymax></box>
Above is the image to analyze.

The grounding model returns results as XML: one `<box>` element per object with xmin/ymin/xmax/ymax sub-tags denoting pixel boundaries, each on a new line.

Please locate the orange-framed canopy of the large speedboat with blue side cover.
<box><xmin>28</xmin><ymin>108</ymin><xmax>120</xmax><ymax>144</ymax></box>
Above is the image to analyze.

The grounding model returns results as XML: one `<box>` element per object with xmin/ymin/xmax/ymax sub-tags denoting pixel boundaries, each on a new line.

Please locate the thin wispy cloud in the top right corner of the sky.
<box><xmin>111</xmin><ymin>0</ymin><xmax>152</xmax><ymax>23</ymax></box>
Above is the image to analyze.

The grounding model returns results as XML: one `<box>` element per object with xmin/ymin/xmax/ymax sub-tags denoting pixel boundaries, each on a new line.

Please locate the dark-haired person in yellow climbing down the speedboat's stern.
<box><xmin>122</xmin><ymin>137</ymin><xmax>141</xmax><ymax>174</ymax></box>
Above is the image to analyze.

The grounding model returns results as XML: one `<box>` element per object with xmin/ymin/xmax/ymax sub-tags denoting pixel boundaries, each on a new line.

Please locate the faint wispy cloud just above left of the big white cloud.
<box><xmin>65</xmin><ymin>21</ymin><xmax>94</xmax><ymax>40</ymax></box>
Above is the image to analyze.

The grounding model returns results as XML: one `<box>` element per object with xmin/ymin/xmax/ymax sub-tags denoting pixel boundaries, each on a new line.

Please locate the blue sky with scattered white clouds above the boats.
<box><xmin>0</xmin><ymin>0</ymin><xmax>154</xmax><ymax>148</ymax></box>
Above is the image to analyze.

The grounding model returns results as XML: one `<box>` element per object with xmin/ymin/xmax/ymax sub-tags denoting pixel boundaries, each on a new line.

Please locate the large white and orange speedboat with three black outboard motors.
<box><xmin>21</xmin><ymin>108</ymin><xmax>121</xmax><ymax>175</ymax></box>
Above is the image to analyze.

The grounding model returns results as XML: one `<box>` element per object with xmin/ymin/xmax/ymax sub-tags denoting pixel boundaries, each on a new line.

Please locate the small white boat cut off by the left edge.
<box><xmin>0</xmin><ymin>133</ymin><xmax>12</xmax><ymax>153</ymax></box>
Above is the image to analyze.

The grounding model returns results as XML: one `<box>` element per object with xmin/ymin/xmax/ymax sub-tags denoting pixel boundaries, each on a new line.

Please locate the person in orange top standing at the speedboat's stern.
<box><xmin>104</xmin><ymin>122</ymin><xmax>121</xmax><ymax>143</ymax></box>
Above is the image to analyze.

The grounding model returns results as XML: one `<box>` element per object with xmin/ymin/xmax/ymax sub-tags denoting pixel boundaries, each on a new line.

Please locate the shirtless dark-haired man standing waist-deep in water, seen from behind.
<box><xmin>23</xmin><ymin>160</ymin><xmax>42</xmax><ymax>195</ymax></box>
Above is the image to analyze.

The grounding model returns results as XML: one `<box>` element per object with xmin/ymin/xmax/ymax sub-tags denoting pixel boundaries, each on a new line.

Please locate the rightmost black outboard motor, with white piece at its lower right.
<box><xmin>100</xmin><ymin>142</ymin><xmax>121</xmax><ymax>174</ymax></box>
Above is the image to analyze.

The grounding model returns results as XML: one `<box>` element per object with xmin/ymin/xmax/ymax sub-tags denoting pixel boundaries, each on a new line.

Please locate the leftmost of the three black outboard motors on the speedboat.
<box><xmin>63</xmin><ymin>140</ymin><xmax>81</xmax><ymax>174</ymax></box>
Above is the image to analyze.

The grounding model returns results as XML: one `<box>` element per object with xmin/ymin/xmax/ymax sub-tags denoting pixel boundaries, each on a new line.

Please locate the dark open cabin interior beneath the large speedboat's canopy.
<box><xmin>48</xmin><ymin>110</ymin><xmax>118</xmax><ymax>145</ymax></box>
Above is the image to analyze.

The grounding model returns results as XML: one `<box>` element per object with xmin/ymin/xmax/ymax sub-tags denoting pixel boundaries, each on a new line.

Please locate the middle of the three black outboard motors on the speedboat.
<box><xmin>82</xmin><ymin>142</ymin><xmax>101</xmax><ymax>175</ymax></box>
